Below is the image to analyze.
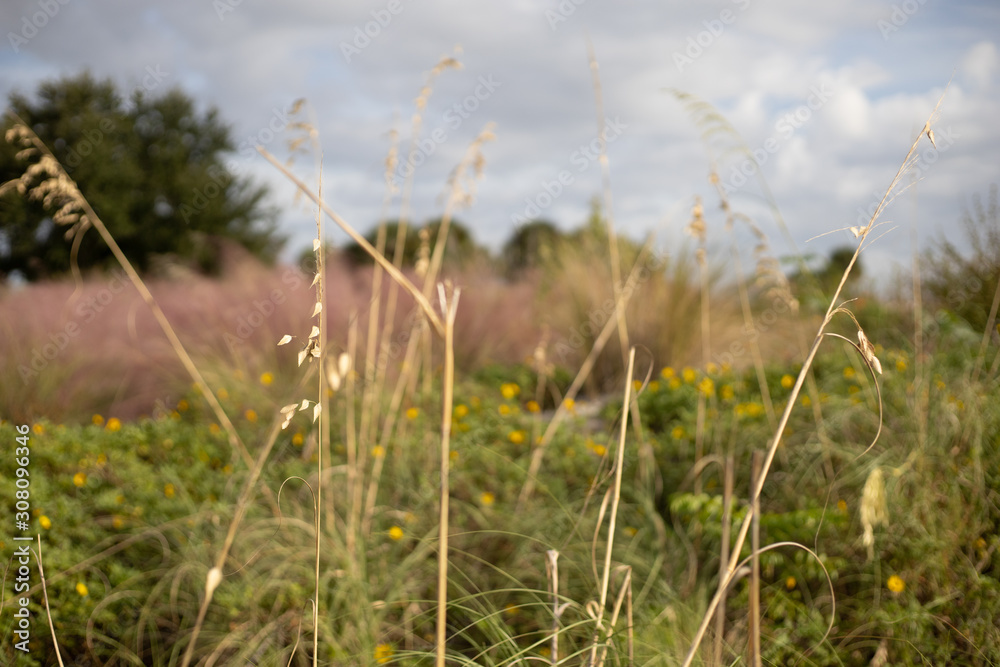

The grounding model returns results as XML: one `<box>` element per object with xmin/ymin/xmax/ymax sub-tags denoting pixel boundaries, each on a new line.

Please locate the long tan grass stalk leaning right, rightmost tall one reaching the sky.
<box><xmin>683</xmin><ymin>95</ymin><xmax>943</xmax><ymax>667</ymax></box>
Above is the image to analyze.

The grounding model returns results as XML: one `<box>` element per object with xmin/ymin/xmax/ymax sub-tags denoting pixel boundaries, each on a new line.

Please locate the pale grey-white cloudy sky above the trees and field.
<box><xmin>0</xmin><ymin>0</ymin><xmax>1000</xmax><ymax>280</ymax></box>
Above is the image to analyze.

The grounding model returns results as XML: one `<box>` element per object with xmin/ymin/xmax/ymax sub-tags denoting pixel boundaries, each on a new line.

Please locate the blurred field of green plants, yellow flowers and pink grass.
<box><xmin>0</xmin><ymin>77</ymin><xmax>1000</xmax><ymax>665</ymax></box>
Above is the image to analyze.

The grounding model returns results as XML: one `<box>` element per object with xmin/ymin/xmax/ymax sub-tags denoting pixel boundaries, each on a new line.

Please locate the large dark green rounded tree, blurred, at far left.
<box><xmin>0</xmin><ymin>72</ymin><xmax>282</xmax><ymax>280</ymax></box>
